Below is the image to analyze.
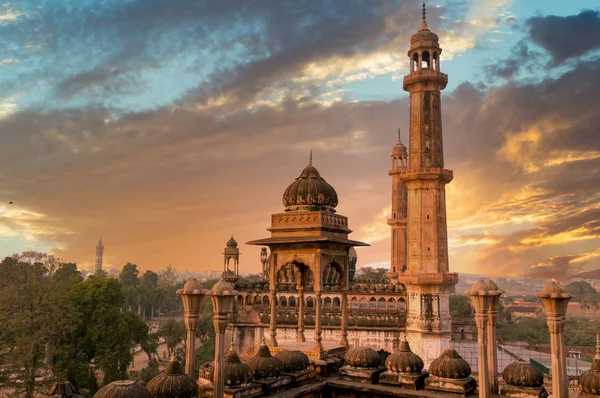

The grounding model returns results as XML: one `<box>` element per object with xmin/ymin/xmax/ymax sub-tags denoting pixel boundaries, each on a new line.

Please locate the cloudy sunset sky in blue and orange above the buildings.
<box><xmin>0</xmin><ymin>0</ymin><xmax>600</xmax><ymax>279</ymax></box>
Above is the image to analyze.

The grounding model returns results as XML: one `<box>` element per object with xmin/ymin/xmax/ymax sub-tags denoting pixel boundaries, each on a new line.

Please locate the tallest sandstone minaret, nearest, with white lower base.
<box><xmin>392</xmin><ymin>4</ymin><xmax>458</xmax><ymax>366</ymax></box>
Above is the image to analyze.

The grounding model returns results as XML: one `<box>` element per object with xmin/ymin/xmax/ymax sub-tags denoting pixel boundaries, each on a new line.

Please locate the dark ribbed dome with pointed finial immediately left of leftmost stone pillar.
<box><xmin>148</xmin><ymin>358</ymin><xmax>198</xmax><ymax>398</ymax></box>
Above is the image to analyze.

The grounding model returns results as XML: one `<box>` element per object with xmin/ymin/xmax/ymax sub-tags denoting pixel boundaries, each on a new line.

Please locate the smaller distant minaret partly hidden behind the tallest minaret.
<box><xmin>387</xmin><ymin>129</ymin><xmax>408</xmax><ymax>283</ymax></box>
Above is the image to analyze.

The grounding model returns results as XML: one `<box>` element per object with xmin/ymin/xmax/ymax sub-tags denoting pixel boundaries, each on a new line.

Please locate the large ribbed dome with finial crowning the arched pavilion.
<box><xmin>282</xmin><ymin>161</ymin><xmax>338</xmax><ymax>211</ymax></box>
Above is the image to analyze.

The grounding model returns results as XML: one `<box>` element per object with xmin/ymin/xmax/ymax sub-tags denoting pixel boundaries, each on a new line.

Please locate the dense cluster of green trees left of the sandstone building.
<box><xmin>0</xmin><ymin>251</ymin><xmax>214</xmax><ymax>398</ymax></box>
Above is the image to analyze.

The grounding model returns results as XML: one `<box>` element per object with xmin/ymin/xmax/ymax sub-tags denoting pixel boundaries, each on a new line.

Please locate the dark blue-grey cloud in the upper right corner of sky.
<box><xmin>526</xmin><ymin>10</ymin><xmax>600</xmax><ymax>66</ymax></box>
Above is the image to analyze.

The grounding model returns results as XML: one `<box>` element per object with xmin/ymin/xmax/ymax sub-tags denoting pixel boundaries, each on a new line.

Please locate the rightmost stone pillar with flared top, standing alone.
<box><xmin>536</xmin><ymin>281</ymin><xmax>573</xmax><ymax>397</ymax></box>
